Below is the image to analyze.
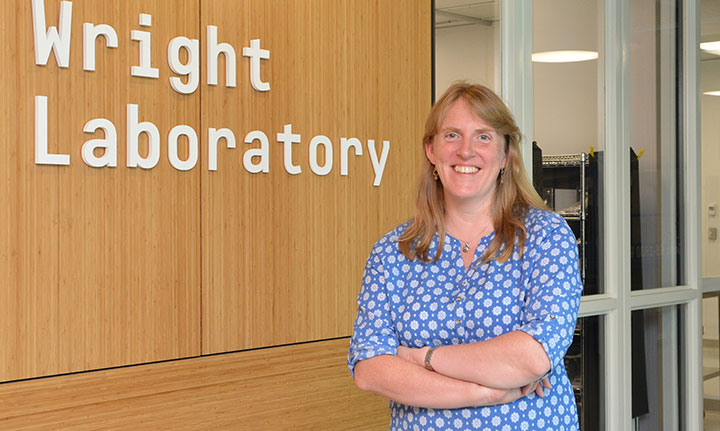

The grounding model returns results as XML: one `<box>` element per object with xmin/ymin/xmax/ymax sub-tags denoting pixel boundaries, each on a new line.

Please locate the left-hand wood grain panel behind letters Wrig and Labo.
<box><xmin>0</xmin><ymin>0</ymin><xmax>200</xmax><ymax>380</ymax></box>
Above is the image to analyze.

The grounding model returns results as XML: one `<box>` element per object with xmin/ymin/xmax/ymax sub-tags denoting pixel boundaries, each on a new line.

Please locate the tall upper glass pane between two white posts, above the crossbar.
<box><xmin>629</xmin><ymin>0</ymin><xmax>683</xmax><ymax>290</ymax></box>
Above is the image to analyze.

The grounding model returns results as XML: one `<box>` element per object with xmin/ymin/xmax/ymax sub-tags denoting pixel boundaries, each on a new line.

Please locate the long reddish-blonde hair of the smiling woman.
<box><xmin>399</xmin><ymin>82</ymin><xmax>547</xmax><ymax>262</ymax></box>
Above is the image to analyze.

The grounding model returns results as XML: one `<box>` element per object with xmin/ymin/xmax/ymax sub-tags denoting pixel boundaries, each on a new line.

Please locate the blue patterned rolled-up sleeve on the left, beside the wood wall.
<box><xmin>348</xmin><ymin>247</ymin><xmax>398</xmax><ymax>377</ymax></box>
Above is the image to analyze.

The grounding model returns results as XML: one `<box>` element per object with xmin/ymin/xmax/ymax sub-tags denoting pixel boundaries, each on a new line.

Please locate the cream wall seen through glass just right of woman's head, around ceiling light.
<box><xmin>532</xmin><ymin>0</ymin><xmax>604</xmax><ymax>155</ymax></box>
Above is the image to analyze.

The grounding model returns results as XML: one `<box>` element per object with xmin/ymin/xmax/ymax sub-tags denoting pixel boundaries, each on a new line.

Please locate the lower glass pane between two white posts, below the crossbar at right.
<box><xmin>631</xmin><ymin>306</ymin><xmax>683</xmax><ymax>431</ymax></box>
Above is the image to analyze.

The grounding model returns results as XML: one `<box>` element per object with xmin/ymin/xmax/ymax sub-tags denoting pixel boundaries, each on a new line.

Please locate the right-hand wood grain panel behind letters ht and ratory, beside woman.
<box><xmin>201</xmin><ymin>0</ymin><xmax>431</xmax><ymax>353</ymax></box>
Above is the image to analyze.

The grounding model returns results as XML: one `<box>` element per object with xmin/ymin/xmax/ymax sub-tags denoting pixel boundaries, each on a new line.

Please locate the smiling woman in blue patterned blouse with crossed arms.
<box><xmin>348</xmin><ymin>83</ymin><xmax>582</xmax><ymax>430</ymax></box>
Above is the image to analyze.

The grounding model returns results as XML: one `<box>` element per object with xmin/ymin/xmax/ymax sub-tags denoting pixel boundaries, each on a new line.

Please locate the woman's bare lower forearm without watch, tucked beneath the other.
<box><xmin>355</xmin><ymin>349</ymin><xmax>536</xmax><ymax>409</ymax></box>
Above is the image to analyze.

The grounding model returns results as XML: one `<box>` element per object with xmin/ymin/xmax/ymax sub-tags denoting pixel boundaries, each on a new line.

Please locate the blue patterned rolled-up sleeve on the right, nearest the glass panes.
<box><xmin>519</xmin><ymin>221</ymin><xmax>582</xmax><ymax>369</ymax></box>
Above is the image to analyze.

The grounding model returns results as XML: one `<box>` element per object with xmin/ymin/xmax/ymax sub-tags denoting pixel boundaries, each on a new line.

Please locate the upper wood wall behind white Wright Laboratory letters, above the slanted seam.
<box><xmin>0</xmin><ymin>0</ymin><xmax>431</xmax><ymax>381</ymax></box>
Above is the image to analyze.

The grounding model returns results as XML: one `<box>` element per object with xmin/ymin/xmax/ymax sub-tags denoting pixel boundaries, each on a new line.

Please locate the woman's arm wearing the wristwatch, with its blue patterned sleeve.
<box><xmin>398</xmin><ymin>216</ymin><xmax>582</xmax><ymax>388</ymax></box>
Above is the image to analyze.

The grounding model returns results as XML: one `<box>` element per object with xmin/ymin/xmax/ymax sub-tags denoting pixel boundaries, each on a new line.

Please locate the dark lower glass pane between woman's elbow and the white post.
<box><xmin>565</xmin><ymin>316</ymin><xmax>605</xmax><ymax>431</ymax></box>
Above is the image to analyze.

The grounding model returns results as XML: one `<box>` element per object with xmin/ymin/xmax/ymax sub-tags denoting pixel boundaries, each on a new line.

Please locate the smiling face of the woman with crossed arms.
<box><xmin>425</xmin><ymin>98</ymin><xmax>506</xmax><ymax>211</ymax></box>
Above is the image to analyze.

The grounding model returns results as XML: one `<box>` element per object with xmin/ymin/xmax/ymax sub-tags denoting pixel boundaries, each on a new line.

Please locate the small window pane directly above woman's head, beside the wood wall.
<box><xmin>434</xmin><ymin>0</ymin><xmax>500</xmax><ymax>100</ymax></box>
